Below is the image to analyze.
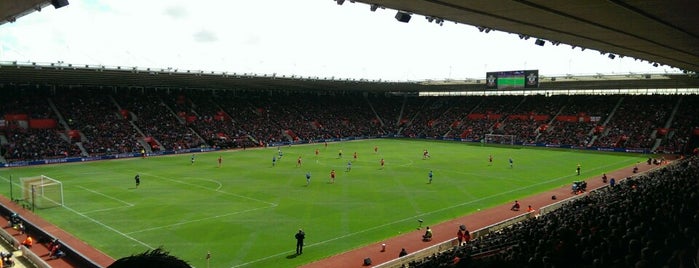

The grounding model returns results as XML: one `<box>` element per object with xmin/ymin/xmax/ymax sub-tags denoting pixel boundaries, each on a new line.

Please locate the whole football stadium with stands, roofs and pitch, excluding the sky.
<box><xmin>0</xmin><ymin>0</ymin><xmax>699</xmax><ymax>268</ymax></box>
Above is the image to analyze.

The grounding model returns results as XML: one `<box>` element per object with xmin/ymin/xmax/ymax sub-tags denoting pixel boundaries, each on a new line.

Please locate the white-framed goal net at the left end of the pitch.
<box><xmin>19</xmin><ymin>175</ymin><xmax>63</xmax><ymax>208</ymax></box>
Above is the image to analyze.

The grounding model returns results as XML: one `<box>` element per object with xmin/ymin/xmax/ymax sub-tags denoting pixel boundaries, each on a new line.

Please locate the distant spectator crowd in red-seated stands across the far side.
<box><xmin>0</xmin><ymin>87</ymin><xmax>699</xmax><ymax>162</ymax></box>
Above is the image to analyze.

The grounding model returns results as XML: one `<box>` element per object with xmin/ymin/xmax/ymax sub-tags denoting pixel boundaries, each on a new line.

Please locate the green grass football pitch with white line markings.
<box><xmin>0</xmin><ymin>139</ymin><xmax>644</xmax><ymax>267</ymax></box>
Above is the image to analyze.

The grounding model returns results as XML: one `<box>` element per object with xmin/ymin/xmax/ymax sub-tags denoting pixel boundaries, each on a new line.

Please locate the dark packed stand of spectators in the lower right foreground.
<box><xmin>409</xmin><ymin>156</ymin><xmax>699</xmax><ymax>268</ymax></box>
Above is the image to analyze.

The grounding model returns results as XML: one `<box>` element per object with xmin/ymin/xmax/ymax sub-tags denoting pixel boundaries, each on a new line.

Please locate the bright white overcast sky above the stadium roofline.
<box><xmin>0</xmin><ymin>0</ymin><xmax>680</xmax><ymax>81</ymax></box>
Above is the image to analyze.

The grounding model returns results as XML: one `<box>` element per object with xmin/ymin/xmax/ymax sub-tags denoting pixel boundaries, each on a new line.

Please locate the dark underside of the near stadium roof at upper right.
<box><xmin>352</xmin><ymin>0</ymin><xmax>699</xmax><ymax>72</ymax></box>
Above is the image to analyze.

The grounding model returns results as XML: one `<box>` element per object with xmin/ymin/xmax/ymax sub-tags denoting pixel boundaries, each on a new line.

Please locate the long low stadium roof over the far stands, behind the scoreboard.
<box><xmin>0</xmin><ymin>62</ymin><xmax>699</xmax><ymax>92</ymax></box>
